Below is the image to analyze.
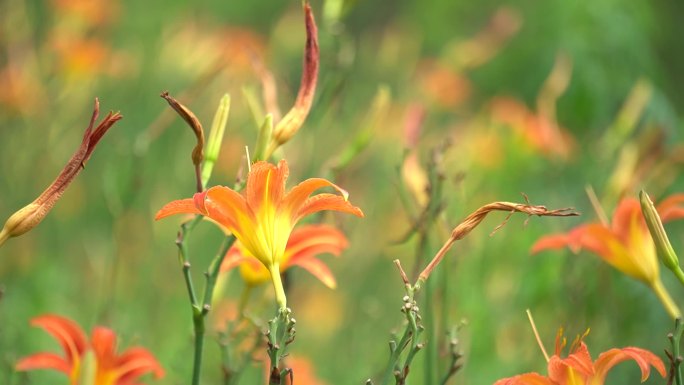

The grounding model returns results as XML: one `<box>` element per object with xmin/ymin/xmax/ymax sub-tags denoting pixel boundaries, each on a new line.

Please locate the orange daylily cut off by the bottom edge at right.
<box><xmin>494</xmin><ymin>330</ymin><xmax>666</xmax><ymax>385</ymax></box>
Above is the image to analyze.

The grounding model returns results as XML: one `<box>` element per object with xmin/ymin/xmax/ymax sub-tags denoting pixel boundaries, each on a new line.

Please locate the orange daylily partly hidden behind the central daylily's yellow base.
<box><xmin>221</xmin><ymin>225</ymin><xmax>349</xmax><ymax>289</ymax></box>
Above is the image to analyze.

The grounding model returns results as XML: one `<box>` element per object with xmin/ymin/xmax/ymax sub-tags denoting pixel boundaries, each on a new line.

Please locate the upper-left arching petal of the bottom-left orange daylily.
<box><xmin>31</xmin><ymin>315</ymin><xmax>88</xmax><ymax>365</ymax></box>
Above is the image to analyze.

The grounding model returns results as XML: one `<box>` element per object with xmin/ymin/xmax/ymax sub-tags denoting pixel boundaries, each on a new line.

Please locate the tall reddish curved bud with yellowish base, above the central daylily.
<box><xmin>272</xmin><ymin>3</ymin><xmax>320</xmax><ymax>149</ymax></box>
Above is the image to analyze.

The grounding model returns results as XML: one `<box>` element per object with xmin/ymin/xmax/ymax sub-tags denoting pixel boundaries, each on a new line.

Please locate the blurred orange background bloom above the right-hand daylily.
<box><xmin>490</xmin><ymin>97</ymin><xmax>575</xmax><ymax>158</ymax></box>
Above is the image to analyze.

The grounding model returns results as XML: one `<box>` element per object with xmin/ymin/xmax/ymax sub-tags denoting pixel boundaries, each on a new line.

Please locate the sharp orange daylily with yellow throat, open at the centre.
<box><xmin>156</xmin><ymin>160</ymin><xmax>363</xmax><ymax>308</ymax></box>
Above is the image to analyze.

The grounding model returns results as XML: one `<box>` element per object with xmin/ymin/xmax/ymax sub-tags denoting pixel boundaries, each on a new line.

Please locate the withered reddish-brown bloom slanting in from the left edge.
<box><xmin>0</xmin><ymin>99</ymin><xmax>122</xmax><ymax>245</ymax></box>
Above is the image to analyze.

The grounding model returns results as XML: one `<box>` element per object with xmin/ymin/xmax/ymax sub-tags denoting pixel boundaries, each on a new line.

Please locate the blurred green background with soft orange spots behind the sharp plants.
<box><xmin>0</xmin><ymin>0</ymin><xmax>684</xmax><ymax>385</ymax></box>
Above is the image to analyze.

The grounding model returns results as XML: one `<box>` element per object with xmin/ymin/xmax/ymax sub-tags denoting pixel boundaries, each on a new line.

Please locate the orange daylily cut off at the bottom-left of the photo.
<box><xmin>16</xmin><ymin>315</ymin><xmax>164</xmax><ymax>385</ymax></box>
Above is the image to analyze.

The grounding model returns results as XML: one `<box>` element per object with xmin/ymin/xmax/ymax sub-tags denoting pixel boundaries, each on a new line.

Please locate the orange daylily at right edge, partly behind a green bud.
<box><xmin>532</xmin><ymin>194</ymin><xmax>684</xmax><ymax>318</ymax></box>
